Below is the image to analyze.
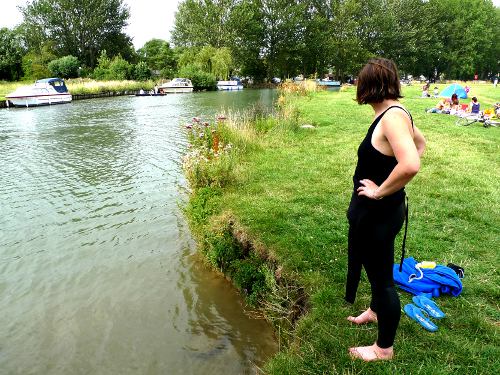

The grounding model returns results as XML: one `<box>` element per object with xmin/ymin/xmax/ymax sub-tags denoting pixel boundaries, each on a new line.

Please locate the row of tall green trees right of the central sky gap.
<box><xmin>173</xmin><ymin>0</ymin><xmax>500</xmax><ymax>79</ymax></box>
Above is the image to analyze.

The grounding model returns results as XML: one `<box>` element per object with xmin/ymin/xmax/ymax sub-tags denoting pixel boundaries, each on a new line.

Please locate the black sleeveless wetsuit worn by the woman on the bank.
<box><xmin>345</xmin><ymin>106</ymin><xmax>413</xmax><ymax>348</ymax></box>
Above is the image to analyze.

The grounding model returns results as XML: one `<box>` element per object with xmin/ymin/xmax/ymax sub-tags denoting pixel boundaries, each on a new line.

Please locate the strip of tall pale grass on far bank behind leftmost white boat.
<box><xmin>0</xmin><ymin>78</ymin><xmax>154</xmax><ymax>100</ymax></box>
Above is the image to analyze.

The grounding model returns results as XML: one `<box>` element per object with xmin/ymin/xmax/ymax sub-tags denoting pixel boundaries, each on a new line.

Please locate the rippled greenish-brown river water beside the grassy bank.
<box><xmin>0</xmin><ymin>90</ymin><xmax>277</xmax><ymax>374</ymax></box>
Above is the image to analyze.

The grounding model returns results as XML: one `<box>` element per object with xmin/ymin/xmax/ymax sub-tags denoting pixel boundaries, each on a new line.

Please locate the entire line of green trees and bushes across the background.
<box><xmin>0</xmin><ymin>0</ymin><xmax>500</xmax><ymax>85</ymax></box>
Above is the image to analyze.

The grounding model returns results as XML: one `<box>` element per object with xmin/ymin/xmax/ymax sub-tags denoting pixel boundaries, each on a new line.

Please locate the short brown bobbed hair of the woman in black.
<box><xmin>356</xmin><ymin>57</ymin><xmax>403</xmax><ymax>104</ymax></box>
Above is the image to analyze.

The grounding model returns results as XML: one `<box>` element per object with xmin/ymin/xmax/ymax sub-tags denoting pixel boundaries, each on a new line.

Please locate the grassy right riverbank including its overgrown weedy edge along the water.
<box><xmin>187</xmin><ymin>85</ymin><xmax>500</xmax><ymax>375</ymax></box>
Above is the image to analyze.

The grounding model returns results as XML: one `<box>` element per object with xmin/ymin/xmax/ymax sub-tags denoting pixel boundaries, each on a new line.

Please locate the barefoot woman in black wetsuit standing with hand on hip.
<box><xmin>346</xmin><ymin>58</ymin><xmax>425</xmax><ymax>361</ymax></box>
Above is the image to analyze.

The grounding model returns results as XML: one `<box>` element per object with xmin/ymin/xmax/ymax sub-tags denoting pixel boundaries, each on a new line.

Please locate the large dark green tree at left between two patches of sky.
<box><xmin>20</xmin><ymin>0</ymin><xmax>133</xmax><ymax>67</ymax></box>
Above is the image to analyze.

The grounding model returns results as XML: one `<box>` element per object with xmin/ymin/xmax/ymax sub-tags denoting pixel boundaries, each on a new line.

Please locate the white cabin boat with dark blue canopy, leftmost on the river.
<box><xmin>5</xmin><ymin>78</ymin><xmax>72</xmax><ymax>107</ymax></box>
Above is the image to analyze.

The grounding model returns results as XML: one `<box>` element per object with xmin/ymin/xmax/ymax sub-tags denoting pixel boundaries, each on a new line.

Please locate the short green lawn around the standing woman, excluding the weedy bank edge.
<box><xmin>188</xmin><ymin>85</ymin><xmax>500</xmax><ymax>375</ymax></box>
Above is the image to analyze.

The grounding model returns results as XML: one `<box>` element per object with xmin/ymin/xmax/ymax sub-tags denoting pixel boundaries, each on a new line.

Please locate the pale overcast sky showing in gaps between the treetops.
<box><xmin>0</xmin><ymin>0</ymin><xmax>500</xmax><ymax>49</ymax></box>
